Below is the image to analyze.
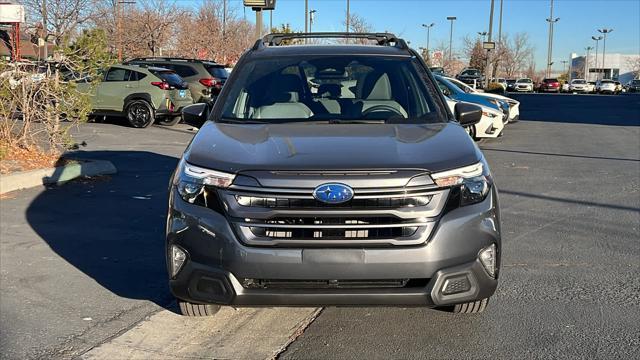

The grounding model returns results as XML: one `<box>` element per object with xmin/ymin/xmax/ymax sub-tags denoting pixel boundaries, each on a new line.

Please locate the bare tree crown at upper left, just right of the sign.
<box><xmin>21</xmin><ymin>0</ymin><xmax>98</xmax><ymax>44</ymax></box>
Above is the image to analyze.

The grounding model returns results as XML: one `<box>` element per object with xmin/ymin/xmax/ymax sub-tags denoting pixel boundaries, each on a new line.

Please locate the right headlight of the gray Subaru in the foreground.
<box><xmin>431</xmin><ymin>162</ymin><xmax>493</xmax><ymax>206</ymax></box>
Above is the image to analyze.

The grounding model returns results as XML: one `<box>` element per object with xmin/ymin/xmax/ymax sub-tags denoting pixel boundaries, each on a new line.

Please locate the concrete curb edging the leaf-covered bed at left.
<box><xmin>0</xmin><ymin>160</ymin><xmax>118</xmax><ymax>194</ymax></box>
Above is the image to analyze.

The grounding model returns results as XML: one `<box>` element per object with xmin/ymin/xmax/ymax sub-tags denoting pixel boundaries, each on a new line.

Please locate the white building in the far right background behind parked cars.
<box><xmin>570</xmin><ymin>52</ymin><xmax>640</xmax><ymax>84</ymax></box>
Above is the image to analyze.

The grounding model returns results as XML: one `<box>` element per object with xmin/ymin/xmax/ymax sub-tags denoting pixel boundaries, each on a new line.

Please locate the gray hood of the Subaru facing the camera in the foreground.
<box><xmin>185</xmin><ymin>122</ymin><xmax>482</xmax><ymax>173</ymax></box>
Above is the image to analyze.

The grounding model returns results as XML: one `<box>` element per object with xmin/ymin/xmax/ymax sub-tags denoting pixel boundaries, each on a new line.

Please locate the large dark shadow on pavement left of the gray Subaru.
<box><xmin>27</xmin><ymin>151</ymin><xmax>178</xmax><ymax>307</ymax></box>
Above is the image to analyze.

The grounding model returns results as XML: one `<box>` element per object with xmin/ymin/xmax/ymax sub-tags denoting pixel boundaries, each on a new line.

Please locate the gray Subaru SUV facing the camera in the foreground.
<box><xmin>166</xmin><ymin>33</ymin><xmax>501</xmax><ymax>316</ymax></box>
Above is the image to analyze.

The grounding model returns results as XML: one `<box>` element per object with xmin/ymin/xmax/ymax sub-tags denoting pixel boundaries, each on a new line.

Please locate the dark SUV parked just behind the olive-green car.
<box><xmin>127</xmin><ymin>57</ymin><xmax>229</xmax><ymax>102</ymax></box>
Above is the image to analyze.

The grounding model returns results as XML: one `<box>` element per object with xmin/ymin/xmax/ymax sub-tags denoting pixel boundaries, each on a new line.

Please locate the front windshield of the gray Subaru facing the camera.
<box><xmin>221</xmin><ymin>55</ymin><xmax>447</xmax><ymax>123</ymax></box>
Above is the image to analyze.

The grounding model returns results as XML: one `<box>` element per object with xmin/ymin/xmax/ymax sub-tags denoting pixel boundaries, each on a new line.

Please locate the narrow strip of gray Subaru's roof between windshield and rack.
<box><xmin>250</xmin><ymin>45</ymin><xmax>411</xmax><ymax>58</ymax></box>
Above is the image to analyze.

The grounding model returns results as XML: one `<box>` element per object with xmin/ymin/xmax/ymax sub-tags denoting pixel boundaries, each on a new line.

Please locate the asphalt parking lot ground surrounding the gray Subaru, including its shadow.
<box><xmin>0</xmin><ymin>94</ymin><xmax>640</xmax><ymax>359</ymax></box>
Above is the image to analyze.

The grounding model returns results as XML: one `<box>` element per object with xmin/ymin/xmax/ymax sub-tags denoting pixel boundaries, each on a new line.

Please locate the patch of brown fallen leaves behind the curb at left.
<box><xmin>0</xmin><ymin>144</ymin><xmax>73</xmax><ymax>174</ymax></box>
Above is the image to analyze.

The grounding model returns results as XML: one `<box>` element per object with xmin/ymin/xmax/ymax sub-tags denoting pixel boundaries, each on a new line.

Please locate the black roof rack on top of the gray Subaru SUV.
<box><xmin>253</xmin><ymin>32</ymin><xmax>409</xmax><ymax>50</ymax></box>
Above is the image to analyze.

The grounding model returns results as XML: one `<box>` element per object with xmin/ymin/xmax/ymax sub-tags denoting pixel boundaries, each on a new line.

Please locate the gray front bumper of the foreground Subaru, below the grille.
<box><xmin>167</xmin><ymin>187</ymin><xmax>501</xmax><ymax>306</ymax></box>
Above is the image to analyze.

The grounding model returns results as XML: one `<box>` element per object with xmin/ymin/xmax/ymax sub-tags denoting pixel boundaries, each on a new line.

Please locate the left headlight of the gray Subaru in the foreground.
<box><xmin>175</xmin><ymin>160</ymin><xmax>236</xmax><ymax>204</ymax></box>
